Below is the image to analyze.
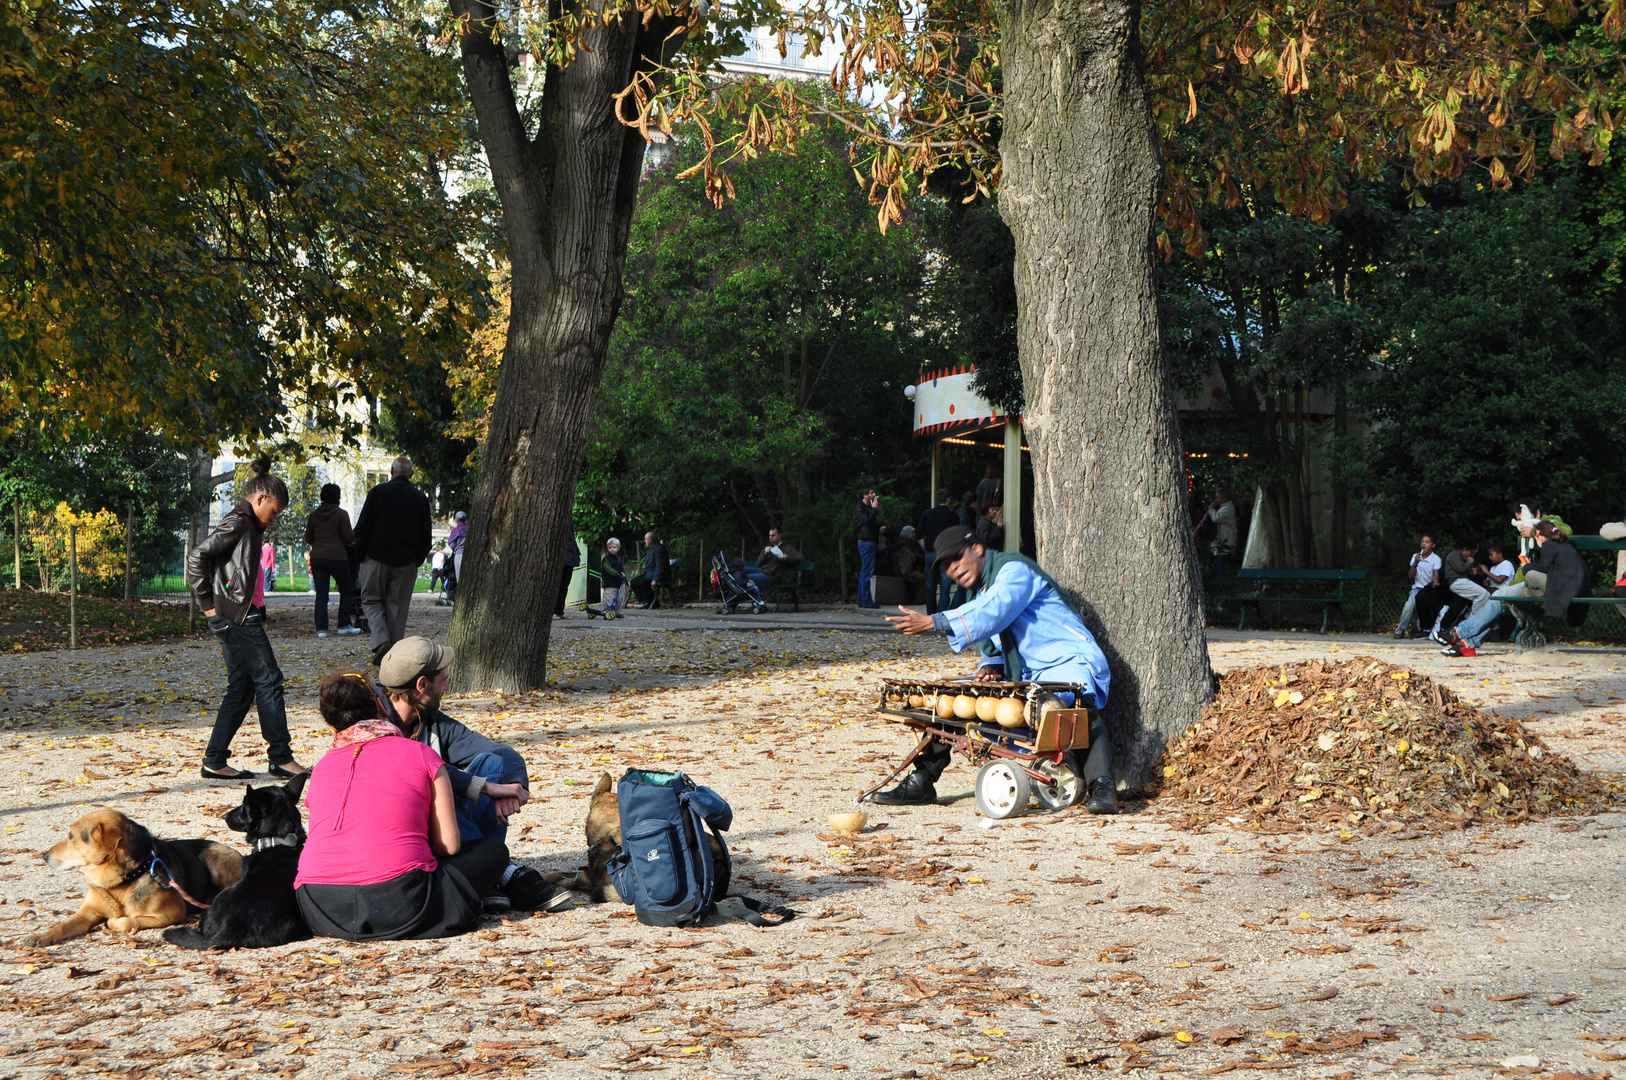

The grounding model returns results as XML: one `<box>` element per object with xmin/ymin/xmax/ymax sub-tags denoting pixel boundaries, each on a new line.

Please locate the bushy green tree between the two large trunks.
<box><xmin>582</xmin><ymin>128</ymin><xmax>945</xmax><ymax>549</ymax></box>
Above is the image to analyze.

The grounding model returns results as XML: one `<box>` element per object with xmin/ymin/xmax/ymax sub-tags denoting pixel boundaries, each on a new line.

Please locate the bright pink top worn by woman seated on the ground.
<box><xmin>294</xmin><ymin>735</ymin><xmax>444</xmax><ymax>888</ymax></box>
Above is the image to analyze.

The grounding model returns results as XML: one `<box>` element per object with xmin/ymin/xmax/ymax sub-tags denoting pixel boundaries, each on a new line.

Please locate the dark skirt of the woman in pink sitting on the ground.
<box><xmin>296</xmin><ymin>839</ymin><xmax>507</xmax><ymax>942</ymax></box>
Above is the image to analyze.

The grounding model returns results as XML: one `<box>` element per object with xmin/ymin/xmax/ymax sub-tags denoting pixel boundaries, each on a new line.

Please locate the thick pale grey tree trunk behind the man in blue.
<box><xmin>1000</xmin><ymin>0</ymin><xmax>1213</xmax><ymax>784</ymax></box>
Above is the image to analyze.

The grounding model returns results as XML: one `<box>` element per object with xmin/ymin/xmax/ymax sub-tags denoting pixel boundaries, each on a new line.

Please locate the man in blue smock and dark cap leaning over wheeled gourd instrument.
<box><xmin>872</xmin><ymin>525</ymin><xmax>1117</xmax><ymax>813</ymax></box>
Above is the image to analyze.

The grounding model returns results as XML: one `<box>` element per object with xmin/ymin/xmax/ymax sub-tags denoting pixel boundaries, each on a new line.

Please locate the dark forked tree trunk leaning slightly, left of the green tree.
<box><xmin>450</xmin><ymin>0</ymin><xmax>672</xmax><ymax>691</ymax></box>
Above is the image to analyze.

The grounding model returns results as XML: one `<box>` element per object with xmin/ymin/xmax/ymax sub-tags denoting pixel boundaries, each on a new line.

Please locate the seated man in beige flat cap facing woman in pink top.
<box><xmin>377</xmin><ymin>638</ymin><xmax>571</xmax><ymax>911</ymax></box>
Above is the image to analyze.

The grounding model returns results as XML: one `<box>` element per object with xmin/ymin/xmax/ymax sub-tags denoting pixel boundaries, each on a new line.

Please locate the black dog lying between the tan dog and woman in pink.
<box><xmin>164</xmin><ymin>773</ymin><xmax>311</xmax><ymax>948</ymax></box>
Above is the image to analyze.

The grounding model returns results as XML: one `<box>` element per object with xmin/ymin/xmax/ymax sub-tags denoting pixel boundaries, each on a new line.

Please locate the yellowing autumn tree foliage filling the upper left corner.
<box><xmin>0</xmin><ymin>0</ymin><xmax>485</xmax><ymax>447</ymax></box>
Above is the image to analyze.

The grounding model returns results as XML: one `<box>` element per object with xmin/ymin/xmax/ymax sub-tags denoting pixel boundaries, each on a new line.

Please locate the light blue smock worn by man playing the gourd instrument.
<box><xmin>932</xmin><ymin>551</ymin><xmax>1112</xmax><ymax>709</ymax></box>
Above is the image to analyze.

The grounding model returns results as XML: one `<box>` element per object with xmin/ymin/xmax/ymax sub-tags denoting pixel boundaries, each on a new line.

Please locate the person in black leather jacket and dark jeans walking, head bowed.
<box><xmin>187</xmin><ymin>459</ymin><xmax>306</xmax><ymax>781</ymax></box>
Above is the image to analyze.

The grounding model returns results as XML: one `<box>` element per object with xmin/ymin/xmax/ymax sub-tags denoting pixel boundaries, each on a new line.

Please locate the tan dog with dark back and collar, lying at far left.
<box><xmin>24</xmin><ymin>810</ymin><xmax>242</xmax><ymax>945</ymax></box>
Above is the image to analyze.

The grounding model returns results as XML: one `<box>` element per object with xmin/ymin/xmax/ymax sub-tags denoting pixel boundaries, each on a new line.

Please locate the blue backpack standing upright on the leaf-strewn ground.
<box><xmin>608</xmin><ymin>769</ymin><xmax>795</xmax><ymax>925</ymax></box>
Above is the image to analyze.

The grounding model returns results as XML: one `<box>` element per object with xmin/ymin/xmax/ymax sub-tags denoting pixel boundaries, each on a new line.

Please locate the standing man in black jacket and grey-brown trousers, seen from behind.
<box><xmin>356</xmin><ymin>454</ymin><xmax>431</xmax><ymax>664</ymax></box>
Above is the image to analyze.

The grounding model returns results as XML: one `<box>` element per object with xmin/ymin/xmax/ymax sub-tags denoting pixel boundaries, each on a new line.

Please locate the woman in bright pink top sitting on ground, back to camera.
<box><xmin>294</xmin><ymin>675</ymin><xmax>509</xmax><ymax>942</ymax></box>
